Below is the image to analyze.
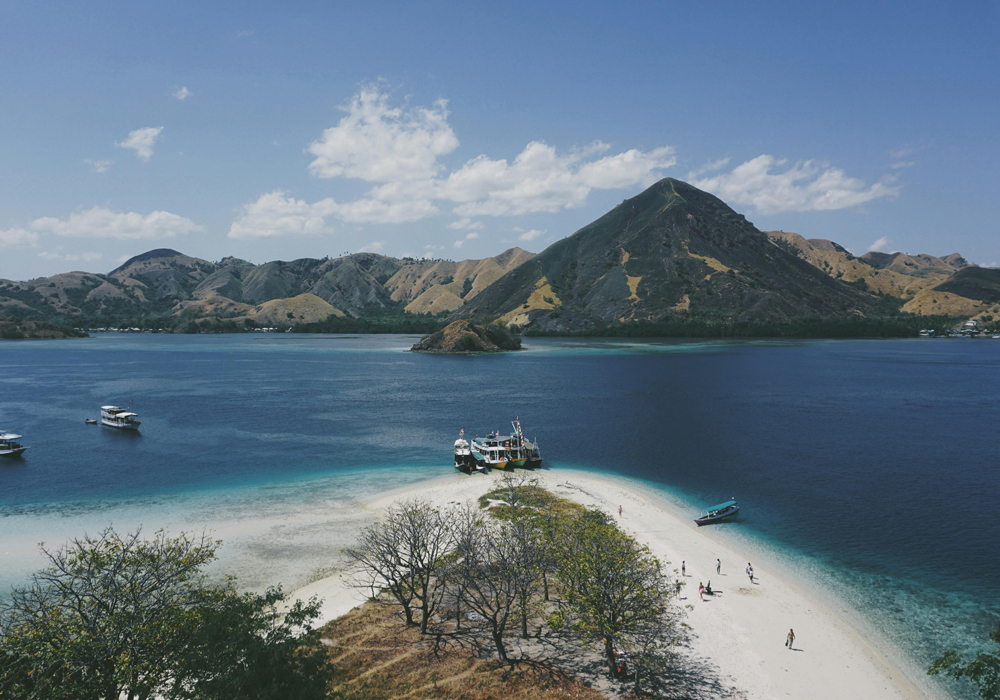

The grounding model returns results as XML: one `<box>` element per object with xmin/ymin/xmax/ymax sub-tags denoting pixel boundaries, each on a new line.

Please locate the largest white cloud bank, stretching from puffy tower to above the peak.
<box><xmin>286</xmin><ymin>86</ymin><xmax>676</xmax><ymax>230</ymax></box>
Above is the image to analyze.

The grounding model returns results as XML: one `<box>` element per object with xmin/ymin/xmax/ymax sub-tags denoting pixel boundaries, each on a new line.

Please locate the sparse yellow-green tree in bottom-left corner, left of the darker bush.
<box><xmin>0</xmin><ymin>528</ymin><xmax>218</xmax><ymax>700</ymax></box>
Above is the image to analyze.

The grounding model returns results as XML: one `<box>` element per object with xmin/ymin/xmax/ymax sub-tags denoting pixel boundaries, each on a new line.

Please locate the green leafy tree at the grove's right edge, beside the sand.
<box><xmin>552</xmin><ymin>510</ymin><xmax>673</xmax><ymax>673</ymax></box>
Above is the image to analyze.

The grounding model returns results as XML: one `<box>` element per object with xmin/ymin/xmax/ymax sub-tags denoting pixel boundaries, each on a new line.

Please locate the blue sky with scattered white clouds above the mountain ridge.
<box><xmin>0</xmin><ymin>0</ymin><xmax>1000</xmax><ymax>279</ymax></box>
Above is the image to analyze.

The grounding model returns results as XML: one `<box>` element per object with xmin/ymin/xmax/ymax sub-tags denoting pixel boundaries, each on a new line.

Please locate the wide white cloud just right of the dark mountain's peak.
<box><xmin>691</xmin><ymin>155</ymin><xmax>899</xmax><ymax>214</ymax></box>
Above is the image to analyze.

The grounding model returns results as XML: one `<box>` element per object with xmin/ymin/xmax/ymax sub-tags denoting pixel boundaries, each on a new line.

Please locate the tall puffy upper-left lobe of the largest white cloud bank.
<box><xmin>308</xmin><ymin>86</ymin><xmax>458</xmax><ymax>182</ymax></box>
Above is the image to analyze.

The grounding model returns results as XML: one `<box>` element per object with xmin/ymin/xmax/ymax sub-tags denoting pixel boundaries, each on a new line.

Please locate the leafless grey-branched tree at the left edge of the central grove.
<box><xmin>344</xmin><ymin>499</ymin><xmax>454</xmax><ymax>633</ymax></box>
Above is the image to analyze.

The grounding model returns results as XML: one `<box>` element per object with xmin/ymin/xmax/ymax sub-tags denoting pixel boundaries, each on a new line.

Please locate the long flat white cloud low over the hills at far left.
<box><xmin>30</xmin><ymin>207</ymin><xmax>202</xmax><ymax>240</ymax></box>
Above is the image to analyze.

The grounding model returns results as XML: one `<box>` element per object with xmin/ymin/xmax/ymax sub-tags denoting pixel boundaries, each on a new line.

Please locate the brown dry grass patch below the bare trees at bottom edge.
<box><xmin>323</xmin><ymin>603</ymin><xmax>603</xmax><ymax>700</ymax></box>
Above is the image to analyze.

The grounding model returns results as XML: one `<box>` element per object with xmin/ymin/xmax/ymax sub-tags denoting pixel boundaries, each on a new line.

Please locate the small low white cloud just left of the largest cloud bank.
<box><xmin>229</xmin><ymin>190</ymin><xmax>336</xmax><ymax>239</ymax></box>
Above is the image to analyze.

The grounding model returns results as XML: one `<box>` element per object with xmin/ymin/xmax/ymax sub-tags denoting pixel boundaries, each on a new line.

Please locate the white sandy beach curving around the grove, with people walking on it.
<box><xmin>296</xmin><ymin>469</ymin><xmax>925</xmax><ymax>700</ymax></box>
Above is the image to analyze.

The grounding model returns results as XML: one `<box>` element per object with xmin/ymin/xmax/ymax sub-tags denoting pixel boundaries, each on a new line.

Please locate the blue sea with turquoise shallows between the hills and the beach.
<box><xmin>0</xmin><ymin>334</ymin><xmax>1000</xmax><ymax>695</ymax></box>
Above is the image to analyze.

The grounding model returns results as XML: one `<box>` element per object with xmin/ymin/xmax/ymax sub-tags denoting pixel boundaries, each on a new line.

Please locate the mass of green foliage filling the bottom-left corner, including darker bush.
<box><xmin>0</xmin><ymin>528</ymin><xmax>330</xmax><ymax>700</ymax></box>
